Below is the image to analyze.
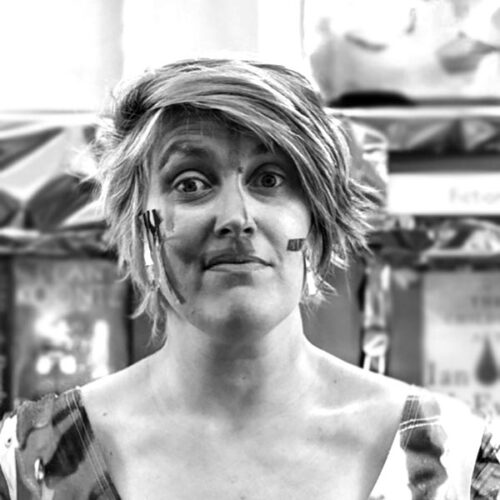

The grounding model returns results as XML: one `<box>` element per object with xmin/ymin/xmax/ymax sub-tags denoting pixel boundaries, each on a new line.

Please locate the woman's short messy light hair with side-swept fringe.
<box><xmin>95</xmin><ymin>59</ymin><xmax>371</xmax><ymax>328</ymax></box>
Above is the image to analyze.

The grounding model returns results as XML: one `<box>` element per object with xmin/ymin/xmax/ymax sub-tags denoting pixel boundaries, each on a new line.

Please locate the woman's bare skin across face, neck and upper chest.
<box><xmin>82</xmin><ymin>122</ymin><xmax>407</xmax><ymax>500</ymax></box>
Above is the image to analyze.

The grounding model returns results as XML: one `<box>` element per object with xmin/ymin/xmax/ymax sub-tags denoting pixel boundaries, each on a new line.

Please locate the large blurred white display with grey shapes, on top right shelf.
<box><xmin>303</xmin><ymin>0</ymin><xmax>500</xmax><ymax>105</ymax></box>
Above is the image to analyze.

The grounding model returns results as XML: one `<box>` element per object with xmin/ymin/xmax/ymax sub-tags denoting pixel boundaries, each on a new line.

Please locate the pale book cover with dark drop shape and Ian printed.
<box><xmin>422</xmin><ymin>271</ymin><xmax>500</xmax><ymax>414</ymax></box>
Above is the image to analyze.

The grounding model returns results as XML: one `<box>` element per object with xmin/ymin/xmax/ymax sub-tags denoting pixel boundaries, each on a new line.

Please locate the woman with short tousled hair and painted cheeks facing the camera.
<box><xmin>0</xmin><ymin>60</ymin><xmax>498</xmax><ymax>500</ymax></box>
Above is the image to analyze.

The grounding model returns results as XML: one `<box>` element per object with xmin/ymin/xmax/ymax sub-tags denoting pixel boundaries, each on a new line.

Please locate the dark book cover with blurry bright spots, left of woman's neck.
<box><xmin>3</xmin><ymin>256</ymin><xmax>130</xmax><ymax>406</ymax></box>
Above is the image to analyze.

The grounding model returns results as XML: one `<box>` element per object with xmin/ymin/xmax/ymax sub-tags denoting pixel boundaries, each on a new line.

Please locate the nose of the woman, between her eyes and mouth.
<box><xmin>214</xmin><ymin>182</ymin><xmax>256</xmax><ymax>238</ymax></box>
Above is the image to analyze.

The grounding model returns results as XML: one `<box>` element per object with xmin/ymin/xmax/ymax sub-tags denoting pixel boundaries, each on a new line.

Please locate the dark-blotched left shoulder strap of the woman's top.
<box><xmin>0</xmin><ymin>390</ymin><xmax>119</xmax><ymax>500</ymax></box>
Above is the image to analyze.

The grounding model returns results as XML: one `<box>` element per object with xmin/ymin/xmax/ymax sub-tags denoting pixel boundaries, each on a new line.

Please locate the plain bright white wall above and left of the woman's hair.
<box><xmin>0</xmin><ymin>0</ymin><xmax>302</xmax><ymax>112</ymax></box>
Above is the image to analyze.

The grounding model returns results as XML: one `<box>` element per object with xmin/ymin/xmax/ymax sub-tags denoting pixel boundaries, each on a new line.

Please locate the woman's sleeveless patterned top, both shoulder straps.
<box><xmin>0</xmin><ymin>387</ymin><xmax>500</xmax><ymax>500</ymax></box>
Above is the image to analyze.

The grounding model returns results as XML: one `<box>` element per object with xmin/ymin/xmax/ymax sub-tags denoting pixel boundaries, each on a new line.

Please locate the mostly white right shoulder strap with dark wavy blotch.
<box><xmin>370</xmin><ymin>389</ymin><xmax>494</xmax><ymax>500</ymax></box>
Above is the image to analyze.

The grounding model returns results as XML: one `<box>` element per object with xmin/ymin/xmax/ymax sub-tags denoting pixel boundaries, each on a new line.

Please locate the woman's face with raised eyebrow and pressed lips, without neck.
<box><xmin>148</xmin><ymin>120</ymin><xmax>311</xmax><ymax>332</ymax></box>
